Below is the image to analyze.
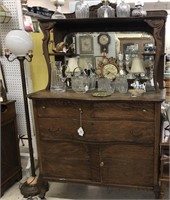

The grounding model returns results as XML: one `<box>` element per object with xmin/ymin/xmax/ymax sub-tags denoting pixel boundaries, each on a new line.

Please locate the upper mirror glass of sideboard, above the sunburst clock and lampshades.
<box><xmin>64</xmin><ymin>32</ymin><xmax>155</xmax><ymax>69</ymax></box>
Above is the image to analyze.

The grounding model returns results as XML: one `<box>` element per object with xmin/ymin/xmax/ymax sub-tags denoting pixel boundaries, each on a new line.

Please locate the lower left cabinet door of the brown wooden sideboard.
<box><xmin>39</xmin><ymin>141</ymin><xmax>91</xmax><ymax>181</ymax></box>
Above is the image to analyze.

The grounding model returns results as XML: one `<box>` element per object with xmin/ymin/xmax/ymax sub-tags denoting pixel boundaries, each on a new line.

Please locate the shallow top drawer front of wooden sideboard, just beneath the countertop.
<box><xmin>37</xmin><ymin>100</ymin><xmax>155</xmax><ymax>121</ymax></box>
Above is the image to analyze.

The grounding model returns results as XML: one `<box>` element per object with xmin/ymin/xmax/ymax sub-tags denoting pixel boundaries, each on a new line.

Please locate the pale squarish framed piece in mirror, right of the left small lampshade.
<box><xmin>78</xmin><ymin>55</ymin><xmax>95</xmax><ymax>70</ymax></box>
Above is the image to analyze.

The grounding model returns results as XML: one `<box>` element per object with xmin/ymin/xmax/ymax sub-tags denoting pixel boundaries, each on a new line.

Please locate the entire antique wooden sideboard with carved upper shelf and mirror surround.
<box><xmin>28</xmin><ymin>4</ymin><xmax>167</xmax><ymax>197</ymax></box>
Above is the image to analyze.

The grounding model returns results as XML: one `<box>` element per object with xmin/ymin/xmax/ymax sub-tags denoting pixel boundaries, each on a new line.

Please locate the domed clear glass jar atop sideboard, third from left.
<box><xmin>116</xmin><ymin>0</ymin><xmax>130</xmax><ymax>17</ymax></box>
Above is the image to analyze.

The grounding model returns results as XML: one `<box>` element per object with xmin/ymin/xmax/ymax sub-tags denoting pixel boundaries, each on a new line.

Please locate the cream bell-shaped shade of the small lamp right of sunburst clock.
<box><xmin>131</xmin><ymin>56</ymin><xmax>145</xmax><ymax>74</ymax></box>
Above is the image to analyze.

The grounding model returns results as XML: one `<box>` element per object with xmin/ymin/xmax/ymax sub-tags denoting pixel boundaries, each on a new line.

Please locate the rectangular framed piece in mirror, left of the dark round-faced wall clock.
<box><xmin>79</xmin><ymin>35</ymin><xmax>94</xmax><ymax>54</ymax></box>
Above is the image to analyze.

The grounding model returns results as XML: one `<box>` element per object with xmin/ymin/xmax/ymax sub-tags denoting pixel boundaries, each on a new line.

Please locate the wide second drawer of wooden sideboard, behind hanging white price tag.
<box><xmin>39</xmin><ymin>118</ymin><xmax>154</xmax><ymax>143</ymax></box>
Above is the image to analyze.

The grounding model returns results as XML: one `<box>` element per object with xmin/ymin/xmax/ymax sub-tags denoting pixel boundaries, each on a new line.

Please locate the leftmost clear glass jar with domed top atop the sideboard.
<box><xmin>75</xmin><ymin>0</ymin><xmax>89</xmax><ymax>18</ymax></box>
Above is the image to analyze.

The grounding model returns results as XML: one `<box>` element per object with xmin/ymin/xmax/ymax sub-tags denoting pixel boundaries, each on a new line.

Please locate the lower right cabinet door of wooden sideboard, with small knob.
<box><xmin>100</xmin><ymin>144</ymin><xmax>154</xmax><ymax>186</ymax></box>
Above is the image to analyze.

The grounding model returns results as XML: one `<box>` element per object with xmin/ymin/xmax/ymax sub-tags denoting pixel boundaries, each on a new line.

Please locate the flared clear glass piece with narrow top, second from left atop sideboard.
<box><xmin>97</xmin><ymin>0</ymin><xmax>115</xmax><ymax>18</ymax></box>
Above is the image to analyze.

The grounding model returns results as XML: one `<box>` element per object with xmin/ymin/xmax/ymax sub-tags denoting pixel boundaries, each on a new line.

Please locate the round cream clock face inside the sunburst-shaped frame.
<box><xmin>103</xmin><ymin>64</ymin><xmax>118</xmax><ymax>80</ymax></box>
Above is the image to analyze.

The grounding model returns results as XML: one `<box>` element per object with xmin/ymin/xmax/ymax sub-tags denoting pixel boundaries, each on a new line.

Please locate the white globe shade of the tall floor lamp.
<box><xmin>5</xmin><ymin>30</ymin><xmax>33</xmax><ymax>57</ymax></box>
